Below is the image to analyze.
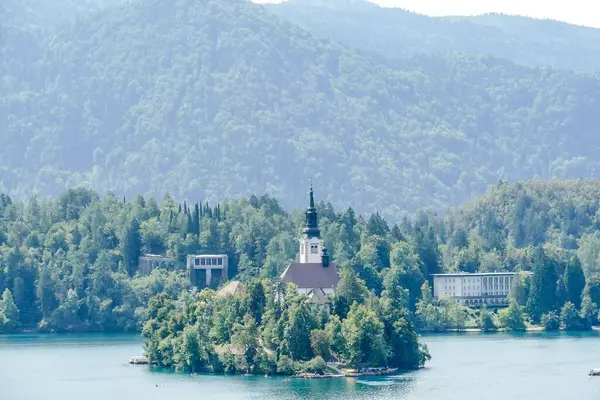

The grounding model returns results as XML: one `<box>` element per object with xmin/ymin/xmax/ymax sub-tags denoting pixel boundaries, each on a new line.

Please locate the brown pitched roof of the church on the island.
<box><xmin>281</xmin><ymin>263</ymin><xmax>340</xmax><ymax>289</ymax></box>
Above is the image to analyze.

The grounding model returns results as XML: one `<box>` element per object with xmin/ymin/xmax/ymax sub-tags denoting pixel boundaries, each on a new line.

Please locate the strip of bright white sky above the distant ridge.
<box><xmin>373</xmin><ymin>0</ymin><xmax>600</xmax><ymax>28</ymax></box>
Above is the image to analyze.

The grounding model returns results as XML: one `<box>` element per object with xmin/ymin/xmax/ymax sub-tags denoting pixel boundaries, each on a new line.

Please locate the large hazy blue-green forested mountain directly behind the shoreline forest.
<box><xmin>0</xmin><ymin>0</ymin><xmax>600</xmax><ymax>221</ymax></box>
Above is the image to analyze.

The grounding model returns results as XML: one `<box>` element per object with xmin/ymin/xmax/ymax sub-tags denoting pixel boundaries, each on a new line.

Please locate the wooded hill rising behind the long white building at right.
<box><xmin>438</xmin><ymin>180</ymin><xmax>600</xmax><ymax>275</ymax></box>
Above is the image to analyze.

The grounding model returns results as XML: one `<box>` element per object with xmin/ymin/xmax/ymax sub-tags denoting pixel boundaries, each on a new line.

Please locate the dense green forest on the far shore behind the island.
<box><xmin>0</xmin><ymin>181</ymin><xmax>600</xmax><ymax>339</ymax></box>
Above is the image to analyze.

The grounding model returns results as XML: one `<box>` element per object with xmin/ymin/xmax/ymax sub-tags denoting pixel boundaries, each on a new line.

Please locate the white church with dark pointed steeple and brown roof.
<box><xmin>281</xmin><ymin>184</ymin><xmax>340</xmax><ymax>304</ymax></box>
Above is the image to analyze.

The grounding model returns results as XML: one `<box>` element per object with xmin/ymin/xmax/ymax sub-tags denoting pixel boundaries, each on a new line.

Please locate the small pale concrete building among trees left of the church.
<box><xmin>187</xmin><ymin>254</ymin><xmax>229</xmax><ymax>288</ymax></box>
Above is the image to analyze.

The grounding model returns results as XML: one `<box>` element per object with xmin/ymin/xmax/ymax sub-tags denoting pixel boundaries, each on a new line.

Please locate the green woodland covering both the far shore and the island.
<box><xmin>0</xmin><ymin>181</ymin><xmax>600</xmax><ymax>374</ymax></box>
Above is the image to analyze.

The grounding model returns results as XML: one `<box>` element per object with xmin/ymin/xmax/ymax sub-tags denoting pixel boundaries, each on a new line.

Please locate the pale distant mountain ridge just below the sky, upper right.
<box><xmin>266</xmin><ymin>0</ymin><xmax>600</xmax><ymax>72</ymax></box>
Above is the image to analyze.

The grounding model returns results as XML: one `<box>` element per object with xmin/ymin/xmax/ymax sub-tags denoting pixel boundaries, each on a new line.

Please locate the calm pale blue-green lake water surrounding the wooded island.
<box><xmin>0</xmin><ymin>332</ymin><xmax>600</xmax><ymax>400</ymax></box>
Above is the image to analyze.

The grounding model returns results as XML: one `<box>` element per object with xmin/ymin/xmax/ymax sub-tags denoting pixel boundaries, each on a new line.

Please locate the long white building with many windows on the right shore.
<box><xmin>433</xmin><ymin>272</ymin><xmax>528</xmax><ymax>307</ymax></box>
